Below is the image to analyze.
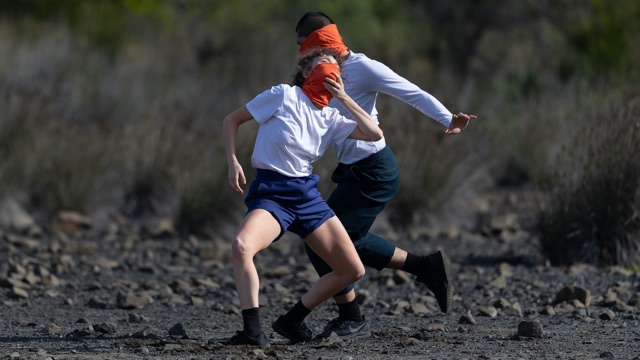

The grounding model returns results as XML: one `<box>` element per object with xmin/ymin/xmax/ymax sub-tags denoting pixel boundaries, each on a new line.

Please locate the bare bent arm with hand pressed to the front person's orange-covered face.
<box><xmin>324</xmin><ymin>73</ymin><xmax>383</xmax><ymax>141</ymax></box>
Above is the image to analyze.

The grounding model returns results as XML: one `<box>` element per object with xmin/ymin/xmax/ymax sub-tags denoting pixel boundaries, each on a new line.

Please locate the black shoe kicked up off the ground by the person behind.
<box><xmin>416</xmin><ymin>251</ymin><xmax>453</xmax><ymax>314</ymax></box>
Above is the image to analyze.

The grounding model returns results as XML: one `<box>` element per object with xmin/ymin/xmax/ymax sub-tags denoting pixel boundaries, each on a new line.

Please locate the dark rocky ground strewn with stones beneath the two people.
<box><xmin>0</xmin><ymin>188</ymin><xmax>640</xmax><ymax>359</ymax></box>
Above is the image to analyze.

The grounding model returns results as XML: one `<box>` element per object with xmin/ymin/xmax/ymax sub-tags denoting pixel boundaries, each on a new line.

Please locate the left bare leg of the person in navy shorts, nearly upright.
<box><xmin>231</xmin><ymin>209</ymin><xmax>281</xmax><ymax>310</ymax></box>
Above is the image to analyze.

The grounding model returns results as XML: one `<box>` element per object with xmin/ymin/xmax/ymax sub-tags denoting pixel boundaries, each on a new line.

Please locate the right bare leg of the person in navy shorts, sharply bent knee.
<box><xmin>302</xmin><ymin>216</ymin><xmax>365</xmax><ymax>309</ymax></box>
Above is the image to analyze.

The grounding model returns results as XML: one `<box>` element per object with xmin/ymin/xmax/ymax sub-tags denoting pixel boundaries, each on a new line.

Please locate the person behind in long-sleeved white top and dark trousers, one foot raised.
<box><xmin>296</xmin><ymin>11</ymin><xmax>476</xmax><ymax>339</ymax></box>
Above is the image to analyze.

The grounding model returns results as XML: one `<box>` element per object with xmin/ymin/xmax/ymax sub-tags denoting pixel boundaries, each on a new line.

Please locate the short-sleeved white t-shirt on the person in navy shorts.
<box><xmin>246</xmin><ymin>84</ymin><xmax>357</xmax><ymax>177</ymax></box>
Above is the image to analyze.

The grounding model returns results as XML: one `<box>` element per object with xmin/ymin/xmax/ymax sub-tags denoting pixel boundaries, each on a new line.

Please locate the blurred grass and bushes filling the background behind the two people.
<box><xmin>0</xmin><ymin>0</ymin><xmax>640</xmax><ymax>263</ymax></box>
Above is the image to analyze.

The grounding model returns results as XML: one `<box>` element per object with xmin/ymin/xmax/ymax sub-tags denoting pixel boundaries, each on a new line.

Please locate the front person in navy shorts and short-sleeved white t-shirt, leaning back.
<box><xmin>223</xmin><ymin>49</ymin><xmax>383</xmax><ymax>346</ymax></box>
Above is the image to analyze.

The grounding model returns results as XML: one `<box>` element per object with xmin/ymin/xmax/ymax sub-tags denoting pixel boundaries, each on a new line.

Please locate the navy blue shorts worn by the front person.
<box><xmin>244</xmin><ymin>169</ymin><xmax>335</xmax><ymax>241</ymax></box>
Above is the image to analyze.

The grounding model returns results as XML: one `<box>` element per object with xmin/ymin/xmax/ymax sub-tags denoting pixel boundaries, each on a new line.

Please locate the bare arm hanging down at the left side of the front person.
<box><xmin>222</xmin><ymin>106</ymin><xmax>253</xmax><ymax>194</ymax></box>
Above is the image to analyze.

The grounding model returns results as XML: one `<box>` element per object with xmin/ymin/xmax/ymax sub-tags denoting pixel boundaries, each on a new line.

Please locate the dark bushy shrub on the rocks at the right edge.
<box><xmin>538</xmin><ymin>98</ymin><xmax>640</xmax><ymax>265</ymax></box>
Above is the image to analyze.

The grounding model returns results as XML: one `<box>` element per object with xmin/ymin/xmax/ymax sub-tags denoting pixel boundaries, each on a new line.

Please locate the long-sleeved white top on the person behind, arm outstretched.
<box><xmin>329</xmin><ymin>51</ymin><xmax>453</xmax><ymax>164</ymax></box>
